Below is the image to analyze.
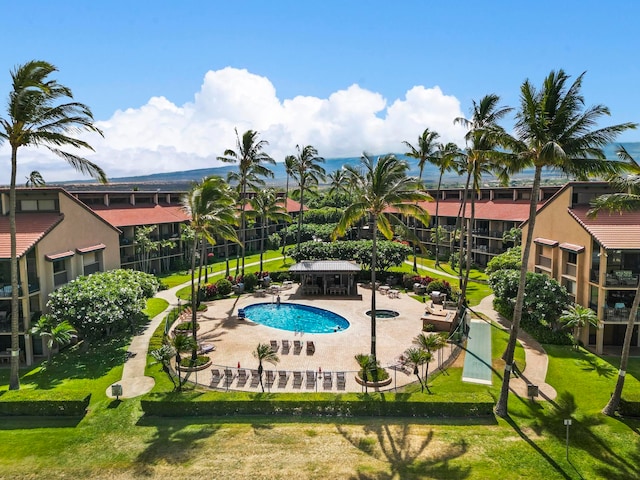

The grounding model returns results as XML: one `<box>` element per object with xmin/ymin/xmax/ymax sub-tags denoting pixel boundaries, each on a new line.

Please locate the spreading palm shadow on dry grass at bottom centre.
<box><xmin>336</xmin><ymin>423</ymin><xmax>471</xmax><ymax>480</ymax></box>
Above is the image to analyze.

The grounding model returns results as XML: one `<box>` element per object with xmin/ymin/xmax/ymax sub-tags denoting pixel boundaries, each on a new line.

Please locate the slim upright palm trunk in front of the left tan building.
<box><xmin>9</xmin><ymin>146</ymin><xmax>20</xmax><ymax>390</ymax></box>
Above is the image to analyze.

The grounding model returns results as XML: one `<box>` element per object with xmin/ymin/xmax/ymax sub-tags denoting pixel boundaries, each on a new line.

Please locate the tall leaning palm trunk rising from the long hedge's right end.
<box><xmin>495</xmin><ymin>166</ymin><xmax>542</xmax><ymax>417</ymax></box>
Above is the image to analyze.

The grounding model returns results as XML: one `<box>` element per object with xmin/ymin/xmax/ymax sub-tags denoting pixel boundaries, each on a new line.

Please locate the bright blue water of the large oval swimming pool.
<box><xmin>244</xmin><ymin>303</ymin><xmax>349</xmax><ymax>333</ymax></box>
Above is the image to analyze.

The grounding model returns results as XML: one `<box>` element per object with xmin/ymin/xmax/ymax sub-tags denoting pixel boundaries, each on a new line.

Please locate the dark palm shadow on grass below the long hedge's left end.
<box><xmin>134</xmin><ymin>418</ymin><xmax>219</xmax><ymax>478</ymax></box>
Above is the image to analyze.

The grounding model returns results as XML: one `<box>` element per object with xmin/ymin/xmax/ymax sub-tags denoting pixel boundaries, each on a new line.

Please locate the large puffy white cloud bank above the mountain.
<box><xmin>0</xmin><ymin>67</ymin><xmax>464</xmax><ymax>184</ymax></box>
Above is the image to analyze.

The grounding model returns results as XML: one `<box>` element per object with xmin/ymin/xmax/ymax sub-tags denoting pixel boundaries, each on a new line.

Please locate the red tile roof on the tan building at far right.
<box><xmin>569</xmin><ymin>206</ymin><xmax>640</xmax><ymax>250</ymax></box>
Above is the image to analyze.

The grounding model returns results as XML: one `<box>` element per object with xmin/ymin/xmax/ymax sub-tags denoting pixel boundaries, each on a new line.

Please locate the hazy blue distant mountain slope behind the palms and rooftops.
<box><xmin>61</xmin><ymin>142</ymin><xmax>640</xmax><ymax>190</ymax></box>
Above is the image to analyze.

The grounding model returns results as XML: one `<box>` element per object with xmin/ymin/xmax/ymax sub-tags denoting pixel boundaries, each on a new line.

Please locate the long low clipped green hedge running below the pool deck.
<box><xmin>141</xmin><ymin>392</ymin><xmax>494</xmax><ymax>417</ymax></box>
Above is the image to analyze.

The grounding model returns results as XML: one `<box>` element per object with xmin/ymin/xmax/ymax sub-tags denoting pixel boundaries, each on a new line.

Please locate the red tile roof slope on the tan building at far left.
<box><xmin>0</xmin><ymin>213</ymin><xmax>64</xmax><ymax>258</ymax></box>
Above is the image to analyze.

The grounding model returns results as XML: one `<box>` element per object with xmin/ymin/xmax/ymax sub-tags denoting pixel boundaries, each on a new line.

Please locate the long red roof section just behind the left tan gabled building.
<box><xmin>92</xmin><ymin>205</ymin><xmax>190</xmax><ymax>227</ymax></box>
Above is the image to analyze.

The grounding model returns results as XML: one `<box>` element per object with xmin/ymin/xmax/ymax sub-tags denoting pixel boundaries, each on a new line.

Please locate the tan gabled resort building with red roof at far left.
<box><xmin>0</xmin><ymin>188</ymin><xmax>120</xmax><ymax>365</ymax></box>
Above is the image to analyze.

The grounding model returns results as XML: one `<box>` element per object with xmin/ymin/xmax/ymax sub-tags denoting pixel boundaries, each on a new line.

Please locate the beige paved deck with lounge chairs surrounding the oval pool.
<box><xmin>184</xmin><ymin>285</ymin><xmax>452</xmax><ymax>392</ymax></box>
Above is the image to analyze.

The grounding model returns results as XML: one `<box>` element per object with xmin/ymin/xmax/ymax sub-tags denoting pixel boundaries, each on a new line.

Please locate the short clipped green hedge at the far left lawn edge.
<box><xmin>0</xmin><ymin>390</ymin><xmax>91</xmax><ymax>417</ymax></box>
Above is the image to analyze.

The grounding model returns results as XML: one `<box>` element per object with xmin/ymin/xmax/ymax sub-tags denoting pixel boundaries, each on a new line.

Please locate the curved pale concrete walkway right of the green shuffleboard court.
<box><xmin>471</xmin><ymin>295</ymin><xmax>557</xmax><ymax>400</ymax></box>
